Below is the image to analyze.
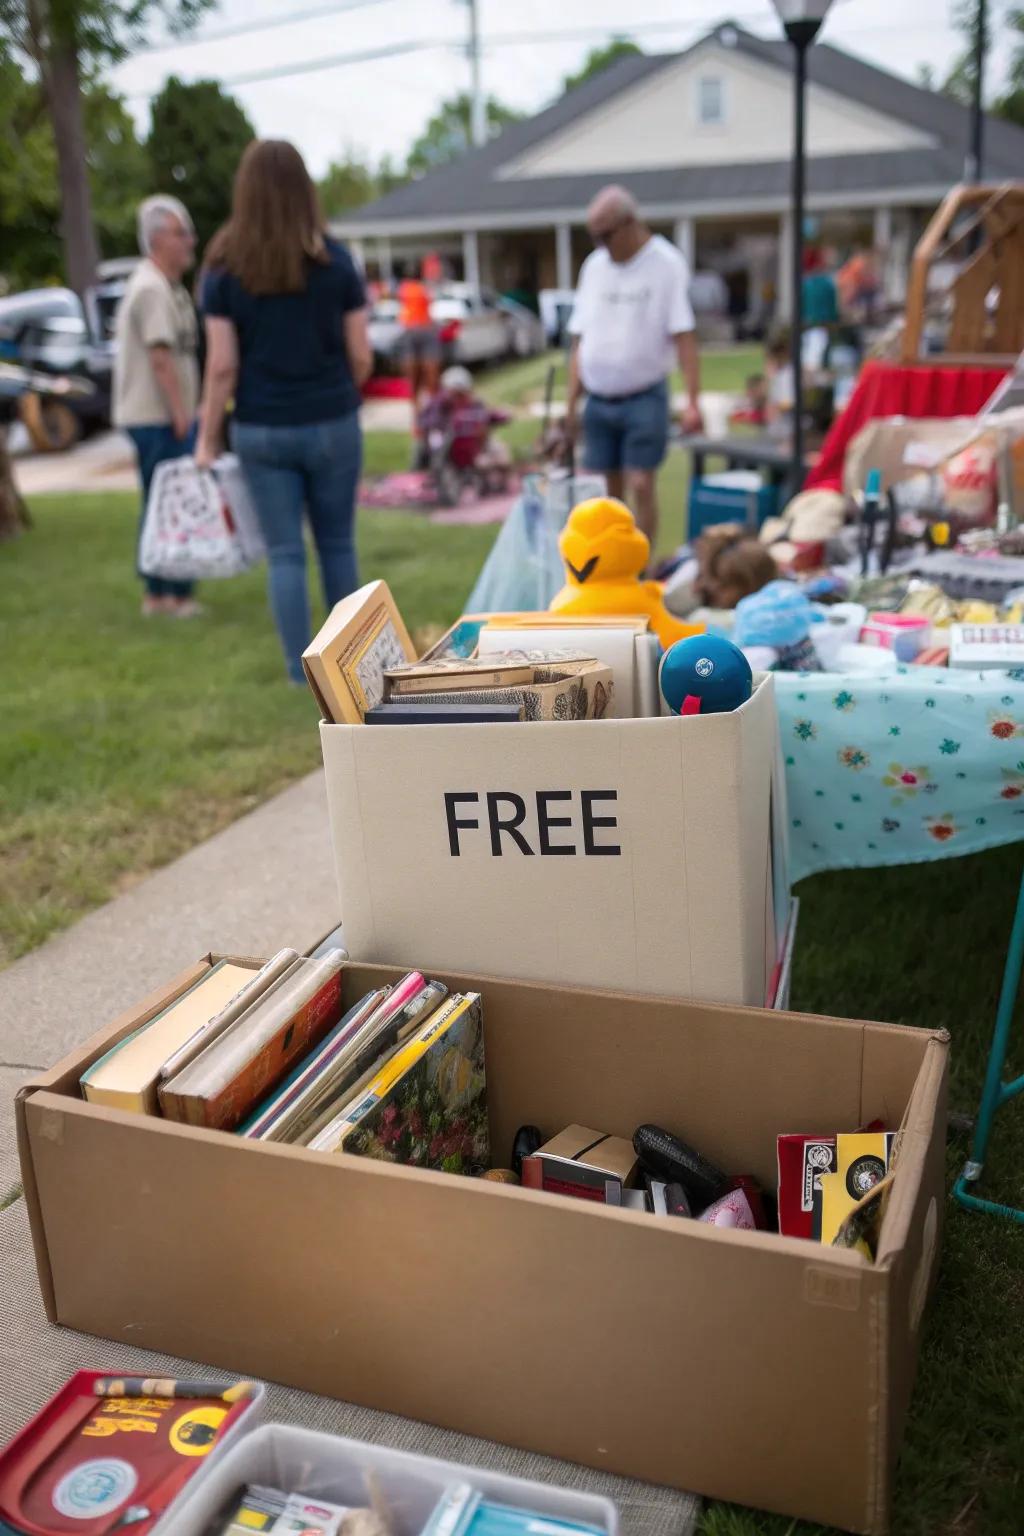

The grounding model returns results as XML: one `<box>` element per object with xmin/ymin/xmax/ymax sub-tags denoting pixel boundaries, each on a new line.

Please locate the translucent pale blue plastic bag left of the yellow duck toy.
<box><xmin>465</xmin><ymin>475</ymin><xmax>605</xmax><ymax>613</ymax></box>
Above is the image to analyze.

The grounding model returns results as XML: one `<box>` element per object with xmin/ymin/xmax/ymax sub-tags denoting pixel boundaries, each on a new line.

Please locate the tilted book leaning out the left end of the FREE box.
<box><xmin>302</xmin><ymin>581</ymin><xmax>416</xmax><ymax>725</ymax></box>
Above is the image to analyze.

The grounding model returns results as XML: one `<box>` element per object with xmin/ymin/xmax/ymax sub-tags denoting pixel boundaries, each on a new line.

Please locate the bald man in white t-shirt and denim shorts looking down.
<box><xmin>567</xmin><ymin>186</ymin><xmax>702</xmax><ymax>545</ymax></box>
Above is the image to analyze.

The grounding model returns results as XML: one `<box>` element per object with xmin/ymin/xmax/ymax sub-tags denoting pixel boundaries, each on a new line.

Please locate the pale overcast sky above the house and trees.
<box><xmin>115</xmin><ymin>0</ymin><xmax>1010</xmax><ymax>175</ymax></box>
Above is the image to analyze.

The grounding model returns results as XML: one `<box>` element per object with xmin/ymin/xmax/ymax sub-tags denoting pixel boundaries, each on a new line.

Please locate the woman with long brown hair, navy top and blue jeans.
<box><xmin>197</xmin><ymin>138</ymin><xmax>372</xmax><ymax>682</ymax></box>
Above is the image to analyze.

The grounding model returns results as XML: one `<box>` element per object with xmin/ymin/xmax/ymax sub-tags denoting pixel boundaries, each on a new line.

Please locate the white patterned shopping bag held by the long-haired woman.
<box><xmin>138</xmin><ymin>453</ymin><xmax>266</xmax><ymax>581</ymax></box>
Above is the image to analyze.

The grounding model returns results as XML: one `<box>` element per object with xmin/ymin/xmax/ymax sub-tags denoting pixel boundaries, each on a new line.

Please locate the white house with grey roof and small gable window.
<box><xmin>333</xmin><ymin>22</ymin><xmax>1024</xmax><ymax>328</ymax></box>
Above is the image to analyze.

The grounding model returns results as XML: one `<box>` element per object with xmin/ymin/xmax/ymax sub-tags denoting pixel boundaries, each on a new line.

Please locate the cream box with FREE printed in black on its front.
<box><xmin>321</xmin><ymin>676</ymin><xmax>785</xmax><ymax>1006</ymax></box>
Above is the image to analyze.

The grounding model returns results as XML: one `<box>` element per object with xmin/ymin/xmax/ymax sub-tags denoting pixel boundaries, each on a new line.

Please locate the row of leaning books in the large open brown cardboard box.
<box><xmin>81</xmin><ymin>949</ymin><xmax>488</xmax><ymax>1174</ymax></box>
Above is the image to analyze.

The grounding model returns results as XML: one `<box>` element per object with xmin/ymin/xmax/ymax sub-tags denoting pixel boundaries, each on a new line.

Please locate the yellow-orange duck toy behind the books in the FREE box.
<box><xmin>551</xmin><ymin>496</ymin><xmax>705</xmax><ymax>648</ymax></box>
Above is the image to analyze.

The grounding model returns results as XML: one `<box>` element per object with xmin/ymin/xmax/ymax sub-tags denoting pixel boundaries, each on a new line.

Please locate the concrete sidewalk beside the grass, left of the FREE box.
<box><xmin>0</xmin><ymin>771</ymin><xmax>338</xmax><ymax>1201</ymax></box>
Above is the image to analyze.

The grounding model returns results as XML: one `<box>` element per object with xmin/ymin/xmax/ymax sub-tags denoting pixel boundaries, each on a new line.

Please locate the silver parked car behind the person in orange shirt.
<box><xmin>368</xmin><ymin>283</ymin><xmax>545</xmax><ymax>372</ymax></box>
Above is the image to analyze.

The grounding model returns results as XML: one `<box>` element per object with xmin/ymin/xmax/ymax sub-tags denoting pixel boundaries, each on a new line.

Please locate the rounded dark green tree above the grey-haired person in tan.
<box><xmin>146</xmin><ymin>75</ymin><xmax>255</xmax><ymax>250</ymax></box>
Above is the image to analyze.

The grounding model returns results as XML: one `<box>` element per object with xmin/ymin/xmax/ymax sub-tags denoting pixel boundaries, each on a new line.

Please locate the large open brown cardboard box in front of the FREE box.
<box><xmin>18</xmin><ymin>957</ymin><xmax>949</xmax><ymax>1533</ymax></box>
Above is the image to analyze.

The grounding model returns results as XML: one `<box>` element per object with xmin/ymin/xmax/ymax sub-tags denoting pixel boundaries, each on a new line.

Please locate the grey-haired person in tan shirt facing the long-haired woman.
<box><xmin>114</xmin><ymin>197</ymin><xmax>200</xmax><ymax>619</ymax></box>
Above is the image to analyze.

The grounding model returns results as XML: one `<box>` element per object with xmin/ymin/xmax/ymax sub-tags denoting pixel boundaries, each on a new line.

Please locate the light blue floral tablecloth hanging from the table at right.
<box><xmin>775</xmin><ymin>667</ymin><xmax>1024</xmax><ymax>880</ymax></box>
